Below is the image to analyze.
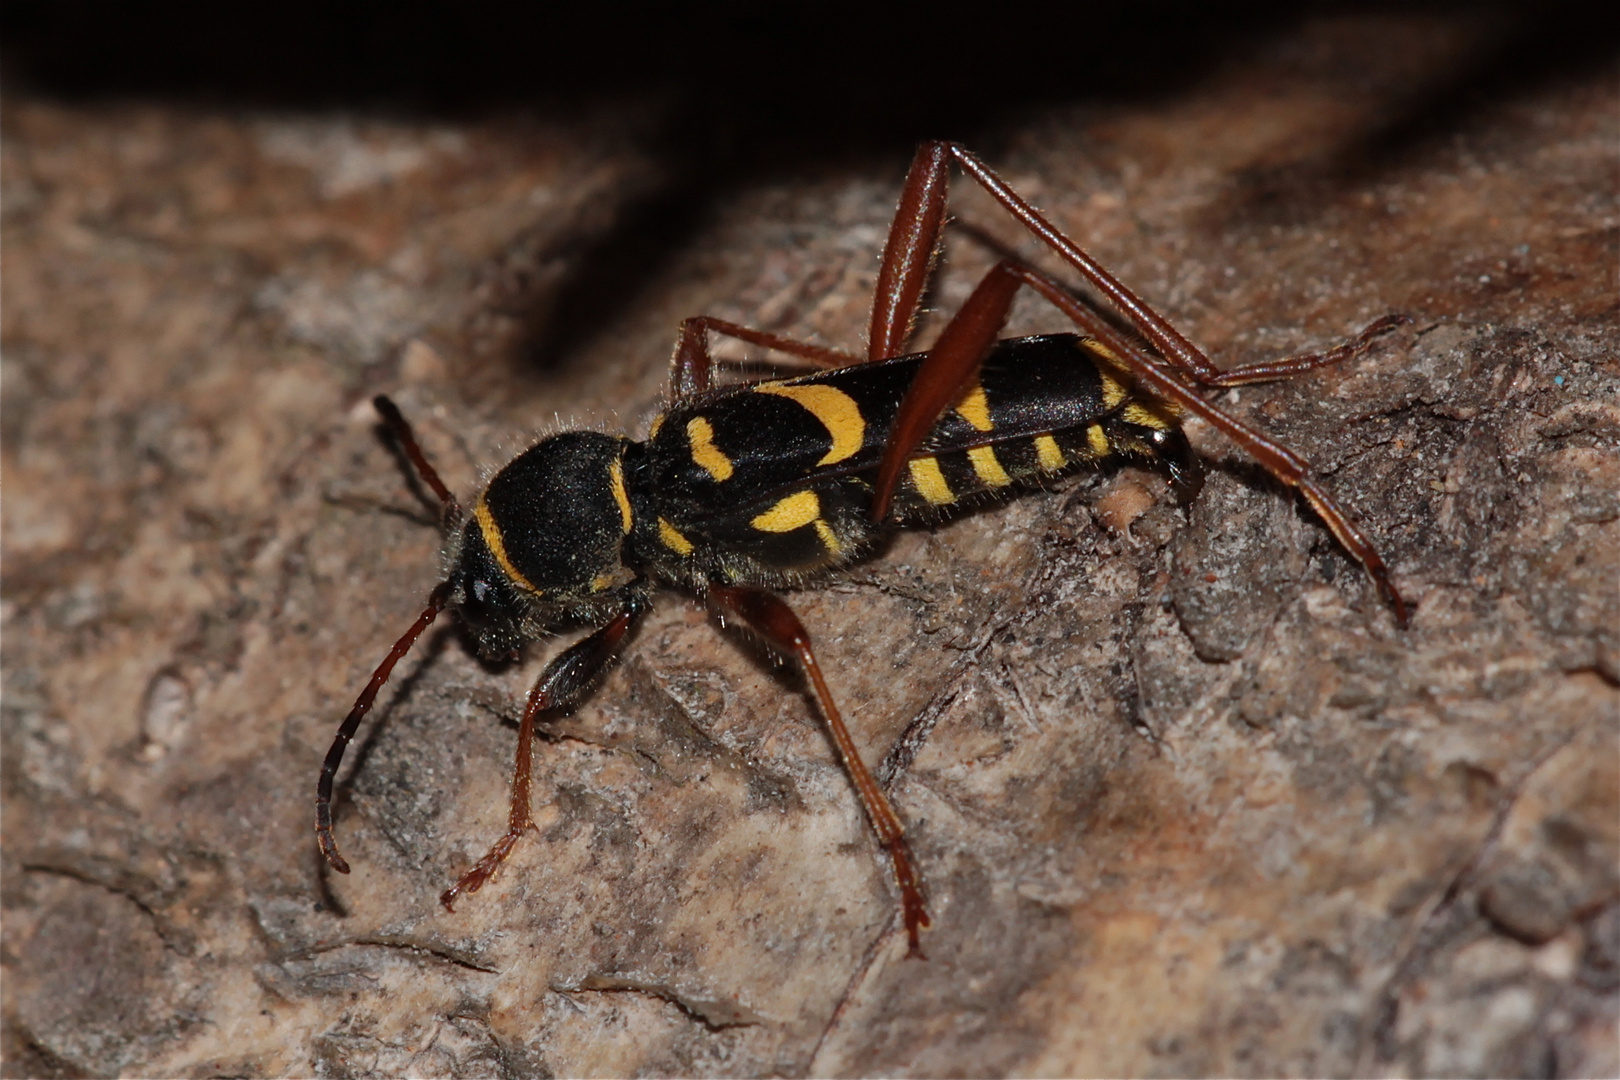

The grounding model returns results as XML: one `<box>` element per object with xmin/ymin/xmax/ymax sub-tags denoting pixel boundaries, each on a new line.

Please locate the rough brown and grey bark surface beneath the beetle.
<box><xmin>3</xmin><ymin>10</ymin><xmax>1620</xmax><ymax>1077</ymax></box>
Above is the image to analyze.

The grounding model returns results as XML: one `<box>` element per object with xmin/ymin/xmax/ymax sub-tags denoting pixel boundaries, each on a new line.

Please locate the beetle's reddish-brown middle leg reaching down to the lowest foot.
<box><xmin>706</xmin><ymin>585</ymin><xmax>930</xmax><ymax>959</ymax></box>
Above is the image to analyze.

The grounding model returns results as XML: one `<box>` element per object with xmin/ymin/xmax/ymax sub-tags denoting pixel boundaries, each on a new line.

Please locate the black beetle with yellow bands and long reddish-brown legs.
<box><xmin>316</xmin><ymin>142</ymin><xmax>1406</xmax><ymax>955</ymax></box>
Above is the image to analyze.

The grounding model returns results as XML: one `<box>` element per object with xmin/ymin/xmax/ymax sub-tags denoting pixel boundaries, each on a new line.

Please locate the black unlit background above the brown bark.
<box><xmin>0</xmin><ymin>0</ymin><xmax>1620</xmax><ymax>162</ymax></box>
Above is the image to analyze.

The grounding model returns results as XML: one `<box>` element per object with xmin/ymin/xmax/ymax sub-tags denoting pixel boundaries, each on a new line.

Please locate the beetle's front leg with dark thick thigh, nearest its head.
<box><xmin>439</xmin><ymin>597</ymin><xmax>645</xmax><ymax>912</ymax></box>
